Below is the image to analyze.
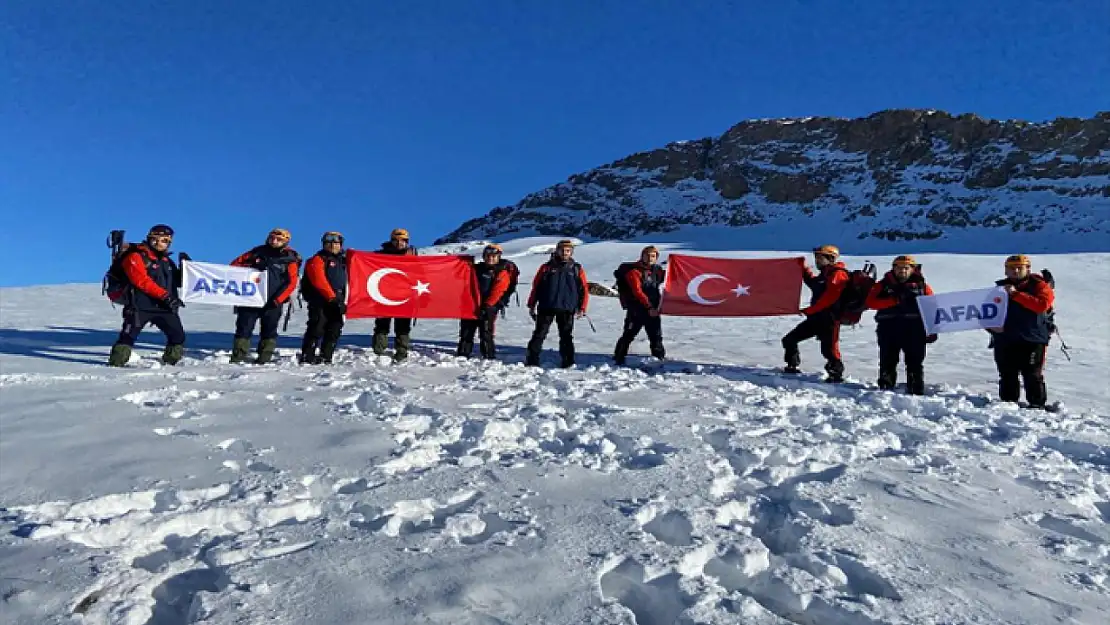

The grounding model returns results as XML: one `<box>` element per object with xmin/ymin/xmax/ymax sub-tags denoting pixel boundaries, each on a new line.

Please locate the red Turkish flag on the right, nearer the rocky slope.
<box><xmin>659</xmin><ymin>254</ymin><xmax>806</xmax><ymax>316</ymax></box>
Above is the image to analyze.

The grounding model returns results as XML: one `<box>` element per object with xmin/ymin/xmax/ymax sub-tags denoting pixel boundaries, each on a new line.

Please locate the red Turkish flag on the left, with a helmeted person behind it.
<box><xmin>346</xmin><ymin>250</ymin><xmax>480</xmax><ymax>319</ymax></box>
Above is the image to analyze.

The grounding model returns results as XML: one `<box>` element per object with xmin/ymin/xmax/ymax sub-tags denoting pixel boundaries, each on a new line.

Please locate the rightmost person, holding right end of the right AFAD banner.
<box><xmin>990</xmin><ymin>254</ymin><xmax>1056</xmax><ymax>410</ymax></box>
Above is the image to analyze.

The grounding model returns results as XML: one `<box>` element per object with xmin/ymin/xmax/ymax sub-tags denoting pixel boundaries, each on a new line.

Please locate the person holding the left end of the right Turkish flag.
<box><xmin>613</xmin><ymin>245</ymin><xmax>666</xmax><ymax>365</ymax></box>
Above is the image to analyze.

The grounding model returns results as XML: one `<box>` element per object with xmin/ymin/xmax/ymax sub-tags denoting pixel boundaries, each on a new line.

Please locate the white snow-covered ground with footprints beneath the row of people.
<box><xmin>0</xmin><ymin>239</ymin><xmax>1110</xmax><ymax>625</ymax></box>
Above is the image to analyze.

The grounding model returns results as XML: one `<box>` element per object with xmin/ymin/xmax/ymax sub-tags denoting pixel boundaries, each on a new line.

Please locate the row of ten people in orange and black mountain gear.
<box><xmin>109</xmin><ymin>225</ymin><xmax>1055</xmax><ymax>407</ymax></box>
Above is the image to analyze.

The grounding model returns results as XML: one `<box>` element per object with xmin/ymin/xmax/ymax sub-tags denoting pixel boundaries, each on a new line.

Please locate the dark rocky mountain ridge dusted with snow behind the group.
<box><xmin>436</xmin><ymin>110</ymin><xmax>1110</xmax><ymax>249</ymax></box>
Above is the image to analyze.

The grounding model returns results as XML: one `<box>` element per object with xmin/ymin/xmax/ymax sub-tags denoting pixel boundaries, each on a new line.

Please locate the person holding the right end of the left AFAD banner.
<box><xmin>231</xmin><ymin>228</ymin><xmax>301</xmax><ymax>364</ymax></box>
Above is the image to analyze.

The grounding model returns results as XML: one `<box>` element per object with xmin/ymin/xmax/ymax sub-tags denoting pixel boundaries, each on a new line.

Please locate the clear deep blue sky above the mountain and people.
<box><xmin>0</xmin><ymin>0</ymin><xmax>1110</xmax><ymax>285</ymax></box>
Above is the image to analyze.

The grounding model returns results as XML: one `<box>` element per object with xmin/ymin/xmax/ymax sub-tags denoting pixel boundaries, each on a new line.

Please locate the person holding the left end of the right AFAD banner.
<box><xmin>866</xmin><ymin>255</ymin><xmax>937</xmax><ymax>395</ymax></box>
